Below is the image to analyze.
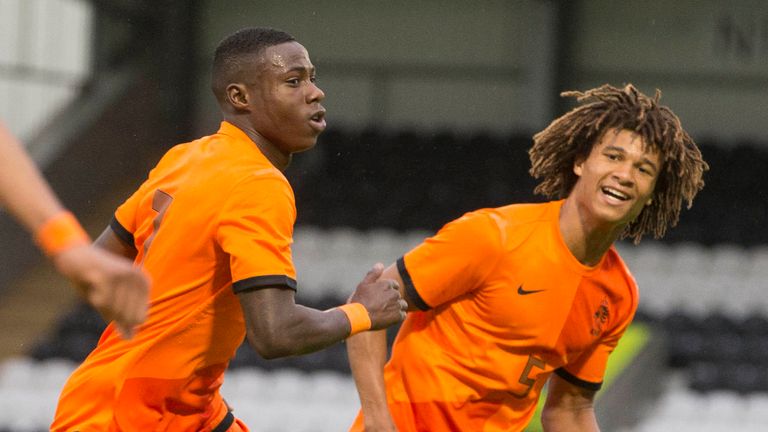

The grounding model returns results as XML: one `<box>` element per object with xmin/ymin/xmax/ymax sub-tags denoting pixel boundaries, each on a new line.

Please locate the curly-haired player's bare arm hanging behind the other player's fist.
<box><xmin>347</xmin><ymin>264</ymin><xmax>416</xmax><ymax>431</ymax></box>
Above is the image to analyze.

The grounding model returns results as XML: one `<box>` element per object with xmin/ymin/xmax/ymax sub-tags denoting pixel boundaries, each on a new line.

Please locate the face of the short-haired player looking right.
<box><xmin>240</xmin><ymin>42</ymin><xmax>326</xmax><ymax>156</ymax></box>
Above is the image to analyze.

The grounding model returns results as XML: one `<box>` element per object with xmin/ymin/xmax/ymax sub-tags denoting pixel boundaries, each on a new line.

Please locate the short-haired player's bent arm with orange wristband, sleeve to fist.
<box><xmin>239</xmin><ymin>264</ymin><xmax>405</xmax><ymax>359</ymax></box>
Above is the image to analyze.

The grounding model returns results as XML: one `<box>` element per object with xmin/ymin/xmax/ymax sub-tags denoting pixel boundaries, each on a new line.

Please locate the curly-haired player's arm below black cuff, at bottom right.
<box><xmin>541</xmin><ymin>374</ymin><xmax>600</xmax><ymax>432</ymax></box>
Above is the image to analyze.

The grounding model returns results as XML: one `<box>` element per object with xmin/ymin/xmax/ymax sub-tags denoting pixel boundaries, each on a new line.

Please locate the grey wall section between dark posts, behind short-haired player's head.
<box><xmin>195</xmin><ymin>0</ymin><xmax>552</xmax><ymax>135</ymax></box>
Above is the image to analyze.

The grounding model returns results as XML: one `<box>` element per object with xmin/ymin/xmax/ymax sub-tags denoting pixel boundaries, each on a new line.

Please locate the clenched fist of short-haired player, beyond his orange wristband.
<box><xmin>348</xmin><ymin>263</ymin><xmax>408</xmax><ymax>330</ymax></box>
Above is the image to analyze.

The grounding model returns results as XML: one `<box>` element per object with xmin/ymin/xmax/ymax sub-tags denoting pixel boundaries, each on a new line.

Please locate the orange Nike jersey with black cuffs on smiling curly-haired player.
<box><xmin>352</xmin><ymin>201</ymin><xmax>638</xmax><ymax>432</ymax></box>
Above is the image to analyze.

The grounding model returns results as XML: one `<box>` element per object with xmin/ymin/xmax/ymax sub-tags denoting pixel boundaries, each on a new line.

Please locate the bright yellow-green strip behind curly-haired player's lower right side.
<box><xmin>525</xmin><ymin>324</ymin><xmax>650</xmax><ymax>432</ymax></box>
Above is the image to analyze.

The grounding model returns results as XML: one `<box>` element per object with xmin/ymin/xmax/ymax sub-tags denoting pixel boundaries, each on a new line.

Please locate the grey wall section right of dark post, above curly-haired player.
<box><xmin>573</xmin><ymin>0</ymin><xmax>768</xmax><ymax>144</ymax></box>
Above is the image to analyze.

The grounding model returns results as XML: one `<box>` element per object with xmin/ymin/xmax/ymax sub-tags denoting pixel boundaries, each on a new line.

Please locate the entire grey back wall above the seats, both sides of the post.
<box><xmin>198</xmin><ymin>0</ymin><xmax>768</xmax><ymax>143</ymax></box>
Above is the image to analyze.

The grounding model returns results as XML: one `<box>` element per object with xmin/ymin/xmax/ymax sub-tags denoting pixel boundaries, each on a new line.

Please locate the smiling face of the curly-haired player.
<box><xmin>569</xmin><ymin>129</ymin><xmax>663</xmax><ymax>226</ymax></box>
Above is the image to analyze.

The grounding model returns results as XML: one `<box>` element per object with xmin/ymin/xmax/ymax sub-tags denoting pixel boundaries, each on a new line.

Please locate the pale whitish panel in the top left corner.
<box><xmin>0</xmin><ymin>0</ymin><xmax>92</xmax><ymax>155</ymax></box>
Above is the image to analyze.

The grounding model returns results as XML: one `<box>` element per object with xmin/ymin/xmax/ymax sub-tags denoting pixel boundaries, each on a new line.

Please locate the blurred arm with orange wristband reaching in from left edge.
<box><xmin>0</xmin><ymin>124</ymin><xmax>149</xmax><ymax>337</ymax></box>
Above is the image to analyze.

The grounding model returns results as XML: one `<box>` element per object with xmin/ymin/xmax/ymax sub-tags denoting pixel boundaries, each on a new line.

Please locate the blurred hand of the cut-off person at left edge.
<box><xmin>53</xmin><ymin>245</ymin><xmax>150</xmax><ymax>338</ymax></box>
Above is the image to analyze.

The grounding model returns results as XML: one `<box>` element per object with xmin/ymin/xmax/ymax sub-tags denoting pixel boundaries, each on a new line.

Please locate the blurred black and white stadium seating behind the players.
<box><xmin>0</xmin><ymin>129</ymin><xmax>768</xmax><ymax>432</ymax></box>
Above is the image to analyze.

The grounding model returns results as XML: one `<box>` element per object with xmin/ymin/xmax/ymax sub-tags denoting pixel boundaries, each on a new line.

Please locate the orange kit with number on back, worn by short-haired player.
<box><xmin>51</xmin><ymin>122</ymin><xmax>296</xmax><ymax>432</ymax></box>
